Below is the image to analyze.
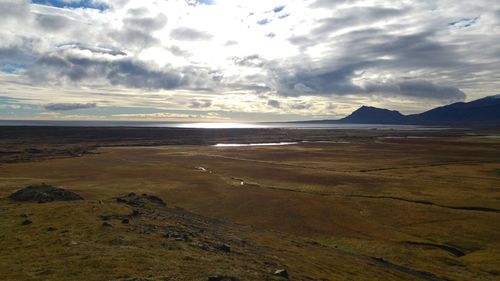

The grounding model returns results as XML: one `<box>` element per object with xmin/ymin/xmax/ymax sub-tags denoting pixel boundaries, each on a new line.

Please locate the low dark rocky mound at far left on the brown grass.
<box><xmin>9</xmin><ymin>183</ymin><xmax>83</xmax><ymax>203</ymax></box>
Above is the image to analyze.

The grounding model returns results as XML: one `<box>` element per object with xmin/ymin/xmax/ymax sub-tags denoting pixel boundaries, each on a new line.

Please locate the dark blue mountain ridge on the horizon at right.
<box><xmin>304</xmin><ymin>95</ymin><xmax>500</xmax><ymax>125</ymax></box>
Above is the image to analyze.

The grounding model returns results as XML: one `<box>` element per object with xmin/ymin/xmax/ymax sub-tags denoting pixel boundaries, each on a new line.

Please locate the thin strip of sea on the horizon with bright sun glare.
<box><xmin>0</xmin><ymin>120</ymin><xmax>443</xmax><ymax>130</ymax></box>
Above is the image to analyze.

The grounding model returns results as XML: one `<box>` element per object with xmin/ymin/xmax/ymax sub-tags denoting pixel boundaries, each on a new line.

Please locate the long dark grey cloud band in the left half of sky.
<box><xmin>27</xmin><ymin>50</ymin><xmax>217</xmax><ymax>90</ymax></box>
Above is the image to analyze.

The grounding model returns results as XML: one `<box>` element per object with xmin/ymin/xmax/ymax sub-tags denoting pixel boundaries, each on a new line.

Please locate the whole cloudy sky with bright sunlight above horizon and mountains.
<box><xmin>0</xmin><ymin>0</ymin><xmax>500</xmax><ymax>122</ymax></box>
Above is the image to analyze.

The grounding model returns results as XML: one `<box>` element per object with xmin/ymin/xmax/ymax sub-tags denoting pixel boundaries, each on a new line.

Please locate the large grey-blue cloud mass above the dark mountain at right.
<box><xmin>274</xmin><ymin>16</ymin><xmax>471</xmax><ymax>101</ymax></box>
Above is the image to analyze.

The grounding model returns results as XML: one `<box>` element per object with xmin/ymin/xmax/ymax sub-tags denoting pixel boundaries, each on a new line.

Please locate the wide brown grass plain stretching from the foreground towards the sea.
<box><xmin>0</xmin><ymin>127</ymin><xmax>500</xmax><ymax>281</ymax></box>
